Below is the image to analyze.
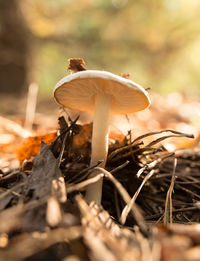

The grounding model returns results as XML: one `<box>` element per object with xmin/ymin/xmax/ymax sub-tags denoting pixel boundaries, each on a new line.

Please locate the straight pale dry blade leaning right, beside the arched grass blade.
<box><xmin>120</xmin><ymin>170</ymin><xmax>155</xmax><ymax>224</ymax></box>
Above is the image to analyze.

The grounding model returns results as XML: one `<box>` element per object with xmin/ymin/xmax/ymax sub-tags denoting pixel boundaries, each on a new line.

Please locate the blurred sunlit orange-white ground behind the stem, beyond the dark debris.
<box><xmin>0</xmin><ymin>92</ymin><xmax>200</xmax><ymax>170</ymax></box>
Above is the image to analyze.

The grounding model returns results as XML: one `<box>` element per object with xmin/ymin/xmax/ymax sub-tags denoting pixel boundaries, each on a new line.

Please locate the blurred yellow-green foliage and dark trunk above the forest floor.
<box><xmin>0</xmin><ymin>0</ymin><xmax>200</xmax><ymax>96</ymax></box>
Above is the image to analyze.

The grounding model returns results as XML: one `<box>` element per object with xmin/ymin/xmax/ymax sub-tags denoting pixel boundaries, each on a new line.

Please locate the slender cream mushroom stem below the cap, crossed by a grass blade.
<box><xmin>86</xmin><ymin>94</ymin><xmax>111</xmax><ymax>204</ymax></box>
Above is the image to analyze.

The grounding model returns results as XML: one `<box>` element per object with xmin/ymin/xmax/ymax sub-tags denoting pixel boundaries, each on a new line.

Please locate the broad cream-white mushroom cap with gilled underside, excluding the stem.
<box><xmin>54</xmin><ymin>70</ymin><xmax>150</xmax><ymax>114</ymax></box>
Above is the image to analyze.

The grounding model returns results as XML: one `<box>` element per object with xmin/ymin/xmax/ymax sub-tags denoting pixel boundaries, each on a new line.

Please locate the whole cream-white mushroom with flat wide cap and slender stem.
<box><xmin>54</xmin><ymin>70</ymin><xmax>150</xmax><ymax>204</ymax></box>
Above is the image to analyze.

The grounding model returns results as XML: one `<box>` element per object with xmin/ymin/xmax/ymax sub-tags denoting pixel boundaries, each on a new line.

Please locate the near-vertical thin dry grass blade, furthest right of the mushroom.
<box><xmin>164</xmin><ymin>158</ymin><xmax>177</xmax><ymax>225</ymax></box>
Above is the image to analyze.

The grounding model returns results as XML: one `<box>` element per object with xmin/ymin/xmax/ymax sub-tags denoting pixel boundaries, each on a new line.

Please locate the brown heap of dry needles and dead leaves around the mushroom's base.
<box><xmin>0</xmin><ymin>118</ymin><xmax>200</xmax><ymax>261</ymax></box>
